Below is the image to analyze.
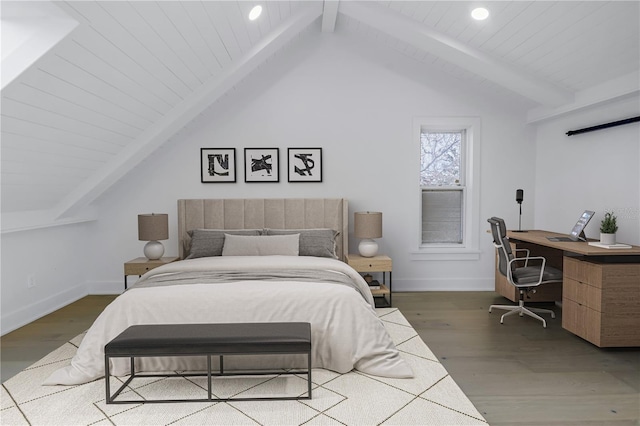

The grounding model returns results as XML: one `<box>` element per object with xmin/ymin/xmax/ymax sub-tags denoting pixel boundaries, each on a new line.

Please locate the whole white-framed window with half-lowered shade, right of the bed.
<box><xmin>414</xmin><ymin>117</ymin><xmax>480</xmax><ymax>259</ymax></box>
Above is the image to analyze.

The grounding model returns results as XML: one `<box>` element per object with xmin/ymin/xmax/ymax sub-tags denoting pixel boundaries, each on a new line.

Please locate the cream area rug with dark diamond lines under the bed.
<box><xmin>0</xmin><ymin>308</ymin><xmax>487</xmax><ymax>426</ymax></box>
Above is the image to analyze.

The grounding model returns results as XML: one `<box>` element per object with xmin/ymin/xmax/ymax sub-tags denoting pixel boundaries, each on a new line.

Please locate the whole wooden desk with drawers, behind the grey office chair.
<box><xmin>496</xmin><ymin>230</ymin><xmax>640</xmax><ymax>347</ymax></box>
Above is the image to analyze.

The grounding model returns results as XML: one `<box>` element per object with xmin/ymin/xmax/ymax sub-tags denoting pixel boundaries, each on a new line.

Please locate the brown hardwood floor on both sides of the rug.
<box><xmin>0</xmin><ymin>292</ymin><xmax>640</xmax><ymax>425</ymax></box>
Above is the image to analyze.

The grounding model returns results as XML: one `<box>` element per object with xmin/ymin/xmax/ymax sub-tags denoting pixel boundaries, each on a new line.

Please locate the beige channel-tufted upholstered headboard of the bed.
<box><xmin>178</xmin><ymin>198</ymin><xmax>349</xmax><ymax>260</ymax></box>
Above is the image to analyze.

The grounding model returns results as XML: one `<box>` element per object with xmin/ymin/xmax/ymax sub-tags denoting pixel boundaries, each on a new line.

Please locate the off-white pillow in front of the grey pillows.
<box><xmin>222</xmin><ymin>234</ymin><xmax>300</xmax><ymax>256</ymax></box>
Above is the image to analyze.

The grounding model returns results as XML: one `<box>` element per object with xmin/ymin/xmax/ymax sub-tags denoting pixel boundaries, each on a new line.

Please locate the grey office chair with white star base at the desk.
<box><xmin>487</xmin><ymin>217</ymin><xmax>562</xmax><ymax>328</ymax></box>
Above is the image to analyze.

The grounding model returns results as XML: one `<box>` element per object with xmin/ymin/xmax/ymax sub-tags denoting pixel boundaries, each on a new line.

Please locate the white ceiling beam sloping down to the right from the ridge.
<box><xmin>340</xmin><ymin>1</ymin><xmax>573</xmax><ymax>107</ymax></box>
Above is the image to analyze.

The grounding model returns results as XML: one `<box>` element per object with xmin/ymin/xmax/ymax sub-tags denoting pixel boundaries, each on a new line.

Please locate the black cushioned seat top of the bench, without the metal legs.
<box><xmin>104</xmin><ymin>322</ymin><xmax>311</xmax><ymax>356</ymax></box>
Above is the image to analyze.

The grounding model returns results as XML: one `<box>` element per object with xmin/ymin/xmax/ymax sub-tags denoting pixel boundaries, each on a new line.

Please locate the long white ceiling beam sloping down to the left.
<box><xmin>55</xmin><ymin>3</ymin><xmax>322</xmax><ymax>220</ymax></box>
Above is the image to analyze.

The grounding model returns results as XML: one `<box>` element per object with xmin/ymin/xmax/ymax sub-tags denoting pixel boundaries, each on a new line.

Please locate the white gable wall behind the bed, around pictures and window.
<box><xmin>85</xmin><ymin>30</ymin><xmax>534</xmax><ymax>290</ymax></box>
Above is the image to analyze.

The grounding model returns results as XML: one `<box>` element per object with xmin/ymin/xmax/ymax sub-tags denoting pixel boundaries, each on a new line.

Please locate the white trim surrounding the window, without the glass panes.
<box><xmin>411</xmin><ymin>117</ymin><xmax>482</xmax><ymax>261</ymax></box>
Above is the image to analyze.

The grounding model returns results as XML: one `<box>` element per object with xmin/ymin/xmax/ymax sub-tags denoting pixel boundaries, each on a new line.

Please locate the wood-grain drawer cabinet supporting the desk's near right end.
<box><xmin>562</xmin><ymin>256</ymin><xmax>640</xmax><ymax>347</ymax></box>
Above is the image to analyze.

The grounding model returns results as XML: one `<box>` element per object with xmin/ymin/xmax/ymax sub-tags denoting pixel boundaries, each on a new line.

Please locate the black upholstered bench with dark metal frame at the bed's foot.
<box><xmin>104</xmin><ymin>322</ymin><xmax>311</xmax><ymax>404</ymax></box>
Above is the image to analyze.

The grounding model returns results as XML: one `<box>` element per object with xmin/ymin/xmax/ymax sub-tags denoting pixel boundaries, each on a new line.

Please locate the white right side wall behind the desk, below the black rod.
<box><xmin>535</xmin><ymin>96</ymin><xmax>640</xmax><ymax>244</ymax></box>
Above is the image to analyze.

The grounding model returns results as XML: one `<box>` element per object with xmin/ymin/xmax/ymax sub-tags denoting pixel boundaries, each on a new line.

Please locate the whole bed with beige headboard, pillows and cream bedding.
<box><xmin>44</xmin><ymin>198</ymin><xmax>413</xmax><ymax>385</ymax></box>
